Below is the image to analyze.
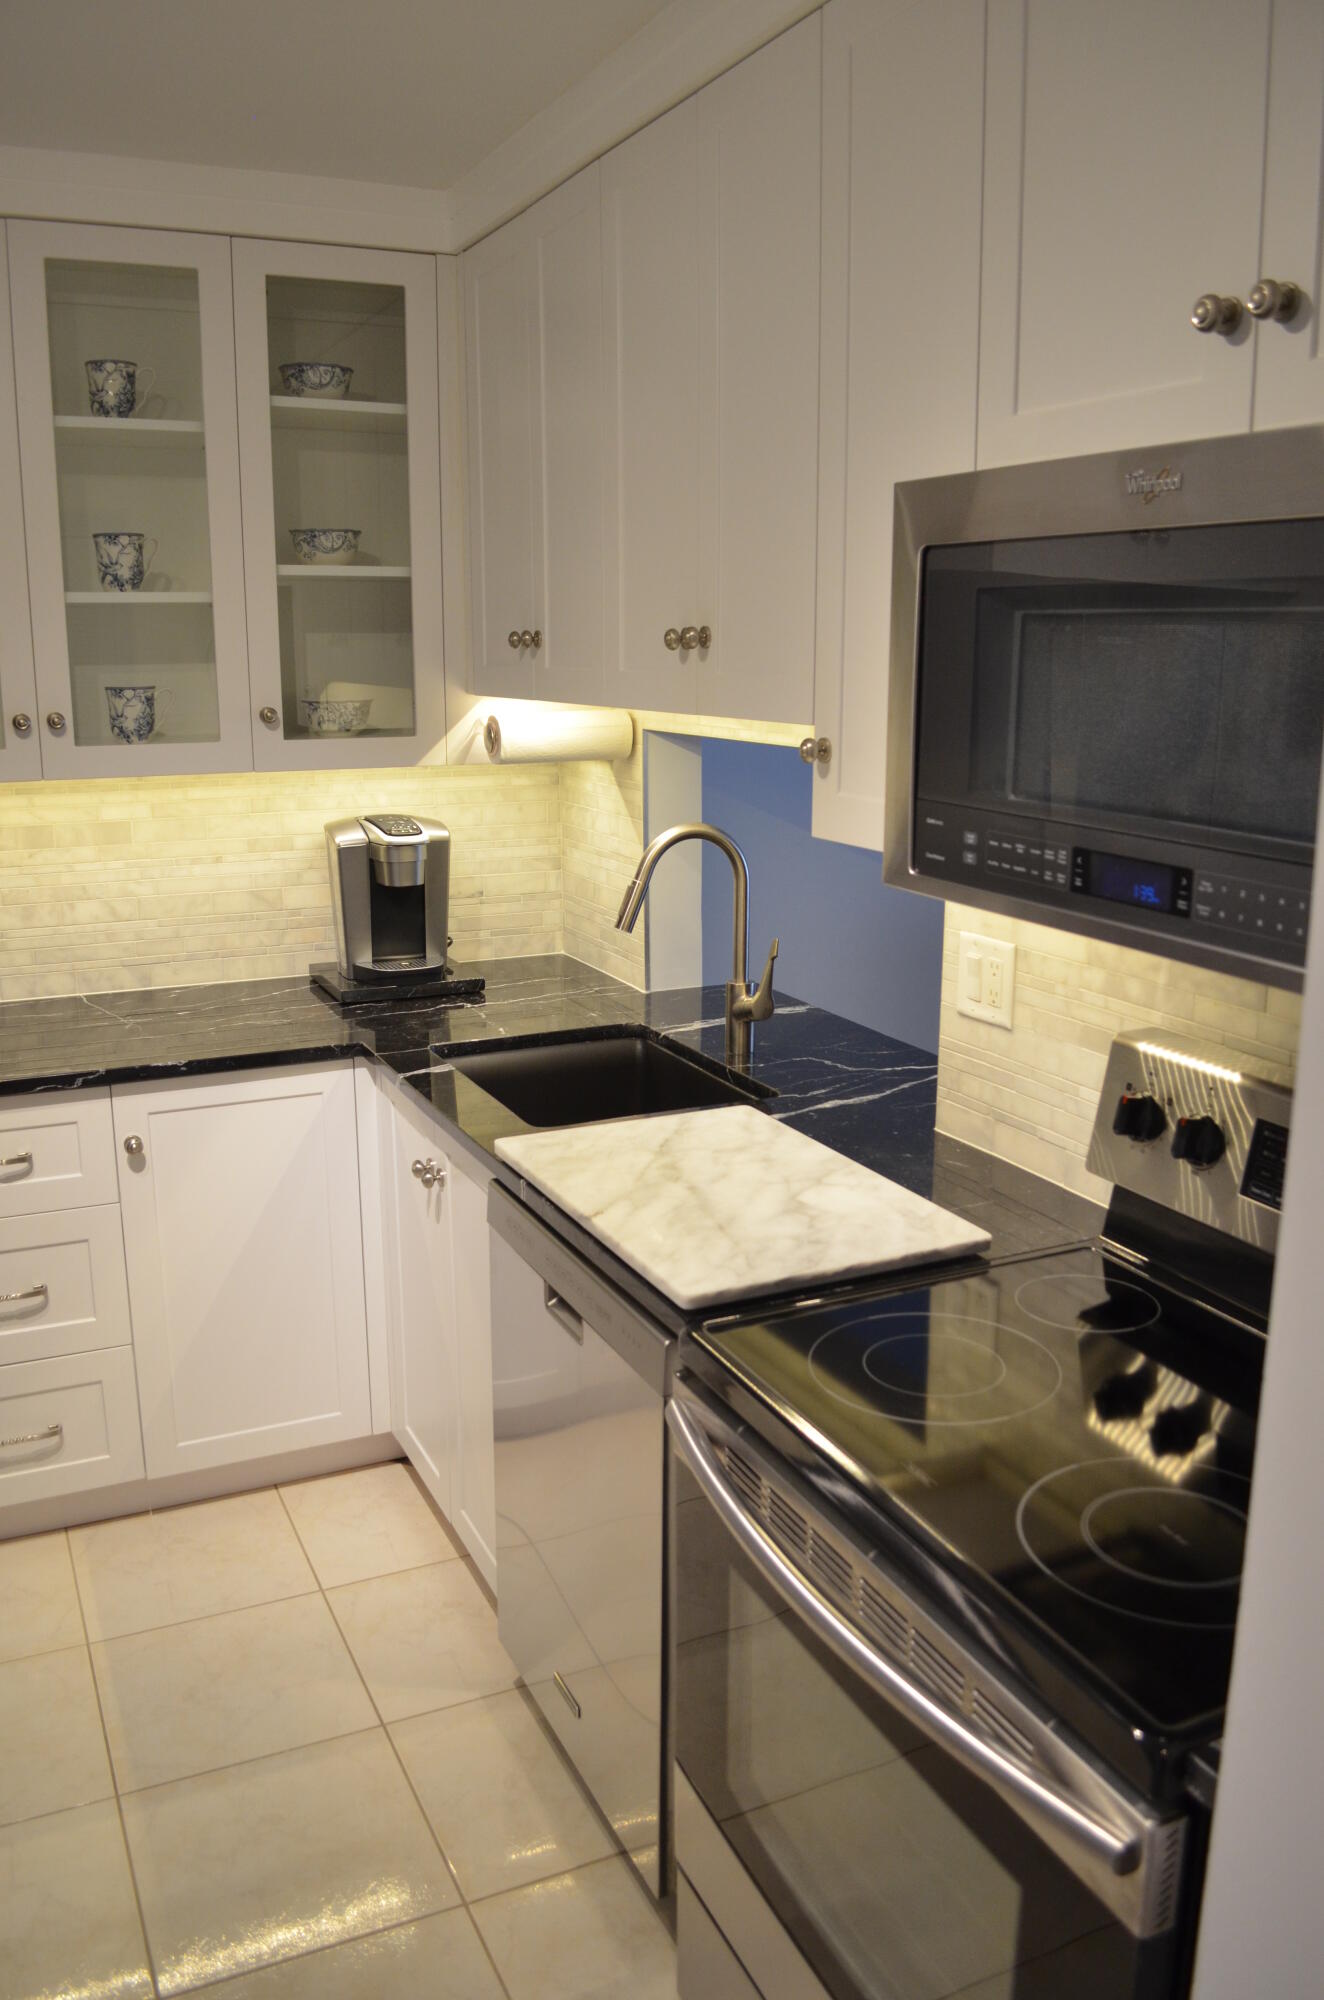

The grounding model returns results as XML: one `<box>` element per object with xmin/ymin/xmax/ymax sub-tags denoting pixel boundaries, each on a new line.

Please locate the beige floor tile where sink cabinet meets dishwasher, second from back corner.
<box><xmin>328</xmin><ymin>1562</ymin><xmax>516</xmax><ymax>1722</ymax></box>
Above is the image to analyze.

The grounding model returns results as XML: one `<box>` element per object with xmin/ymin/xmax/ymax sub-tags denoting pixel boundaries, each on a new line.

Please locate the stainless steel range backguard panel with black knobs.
<box><xmin>1088</xmin><ymin>1028</ymin><xmax>1292</xmax><ymax>1252</ymax></box>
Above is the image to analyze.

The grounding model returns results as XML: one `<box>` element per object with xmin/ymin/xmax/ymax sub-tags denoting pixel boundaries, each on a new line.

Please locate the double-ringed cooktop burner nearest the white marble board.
<box><xmin>808</xmin><ymin>1310</ymin><xmax>1062</xmax><ymax>1430</ymax></box>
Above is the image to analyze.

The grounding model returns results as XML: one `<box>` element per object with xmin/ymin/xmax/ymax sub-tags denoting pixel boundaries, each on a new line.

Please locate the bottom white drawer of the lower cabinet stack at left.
<box><xmin>0</xmin><ymin>1348</ymin><xmax>142</xmax><ymax>1506</ymax></box>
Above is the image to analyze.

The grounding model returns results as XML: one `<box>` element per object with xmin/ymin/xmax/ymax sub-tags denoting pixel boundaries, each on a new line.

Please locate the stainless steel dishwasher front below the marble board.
<box><xmin>488</xmin><ymin>1184</ymin><xmax>674</xmax><ymax>1896</ymax></box>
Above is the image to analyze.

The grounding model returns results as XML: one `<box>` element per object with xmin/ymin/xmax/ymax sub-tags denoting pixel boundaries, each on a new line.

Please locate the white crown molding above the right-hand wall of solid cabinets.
<box><xmin>444</xmin><ymin>0</ymin><xmax>824</xmax><ymax>250</ymax></box>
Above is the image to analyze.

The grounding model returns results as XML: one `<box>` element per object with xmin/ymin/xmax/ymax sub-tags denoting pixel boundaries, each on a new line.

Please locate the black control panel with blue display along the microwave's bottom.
<box><xmin>912</xmin><ymin>800</ymin><xmax>1310</xmax><ymax>966</ymax></box>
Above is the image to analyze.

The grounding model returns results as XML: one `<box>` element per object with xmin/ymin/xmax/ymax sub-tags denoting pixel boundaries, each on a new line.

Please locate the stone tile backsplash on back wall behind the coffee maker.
<box><xmin>0</xmin><ymin>764</ymin><xmax>584</xmax><ymax>1000</ymax></box>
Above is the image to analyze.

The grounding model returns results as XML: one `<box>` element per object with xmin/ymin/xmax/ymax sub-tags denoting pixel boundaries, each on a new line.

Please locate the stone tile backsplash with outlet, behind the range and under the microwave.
<box><xmin>938</xmin><ymin>902</ymin><xmax>1300</xmax><ymax>1200</ymax></box>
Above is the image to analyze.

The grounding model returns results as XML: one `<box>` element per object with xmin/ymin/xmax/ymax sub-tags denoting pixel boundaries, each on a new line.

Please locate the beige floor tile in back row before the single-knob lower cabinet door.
<box><xmin>70</xmin><ymin>1488</ymin><xmax>316</xmax><ymax>1640</ymax></box>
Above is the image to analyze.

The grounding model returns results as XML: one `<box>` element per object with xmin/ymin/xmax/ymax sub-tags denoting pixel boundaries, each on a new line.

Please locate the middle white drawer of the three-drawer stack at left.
<box><xmin>0</xmin><ymin>1202</ymin><xmax>132</xmax><ymax>1366</ymax></box>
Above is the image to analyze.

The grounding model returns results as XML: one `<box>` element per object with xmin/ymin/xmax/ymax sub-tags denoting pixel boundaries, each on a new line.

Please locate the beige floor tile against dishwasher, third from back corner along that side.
<box><xmin>390</xmin><ymin>1690</ymin><xmax>614</xmax><ymax>1900</ymax></box>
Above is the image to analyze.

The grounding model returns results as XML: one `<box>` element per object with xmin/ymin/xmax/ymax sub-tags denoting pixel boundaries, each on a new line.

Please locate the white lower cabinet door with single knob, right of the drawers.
<box><xmin>114</xmin><ymin>1062</ymin><xmax>372</xmax><ymax>1478</ymax></box>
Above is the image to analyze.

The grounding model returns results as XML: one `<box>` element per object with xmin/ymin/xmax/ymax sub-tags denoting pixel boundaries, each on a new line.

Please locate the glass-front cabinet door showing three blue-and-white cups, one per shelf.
<box><xmin>0</xmin><ymin>222</ymin><xmax>252</xmax><ymax>778</ymax></box>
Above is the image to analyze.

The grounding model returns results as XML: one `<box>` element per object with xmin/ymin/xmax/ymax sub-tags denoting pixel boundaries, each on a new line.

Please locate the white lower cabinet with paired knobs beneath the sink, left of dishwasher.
<box><xmin>378</xmin><ymin>1088</ymin><xmax>496</xmax><ymax>1588</ymax></box>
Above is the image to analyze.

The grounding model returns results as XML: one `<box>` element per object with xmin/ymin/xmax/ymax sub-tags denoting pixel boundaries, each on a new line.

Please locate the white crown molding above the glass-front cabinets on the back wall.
<box><xmin>0</xmin><ymin>146</ymin><xmax>454</xmax><ymax>252</ymax></box>
